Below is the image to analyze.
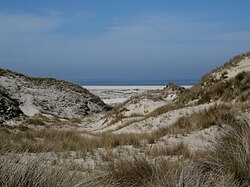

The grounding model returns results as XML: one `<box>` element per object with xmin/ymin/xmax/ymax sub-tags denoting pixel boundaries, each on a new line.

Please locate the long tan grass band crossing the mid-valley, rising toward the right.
<box><xmin>0</xmin><ymin>104</ymin><xmax>241</xmax><ymax>155</ymax></box>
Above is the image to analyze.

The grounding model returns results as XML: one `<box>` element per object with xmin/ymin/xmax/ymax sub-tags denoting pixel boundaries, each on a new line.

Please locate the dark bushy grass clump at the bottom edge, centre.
<box><xmin>94</xmin><ymin>156</ymin><xmax>181</xmax><ymax>187</ymax></box>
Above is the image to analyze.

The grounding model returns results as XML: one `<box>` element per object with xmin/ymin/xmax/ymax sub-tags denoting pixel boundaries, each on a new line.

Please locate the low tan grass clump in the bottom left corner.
<box><xmin>0</xmin><ymin>155</ymin><xmax>83</xmax><ymax>187</ymax></box>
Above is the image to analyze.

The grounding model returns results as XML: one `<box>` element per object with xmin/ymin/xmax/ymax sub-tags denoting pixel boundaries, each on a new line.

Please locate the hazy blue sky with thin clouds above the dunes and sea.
<box><xmin>0</xmin><ymin>0</ymin><xmax>250</xmax><ymax>81</ymax></box>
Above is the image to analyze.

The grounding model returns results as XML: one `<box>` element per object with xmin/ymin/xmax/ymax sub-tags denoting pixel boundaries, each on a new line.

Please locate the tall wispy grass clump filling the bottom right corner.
<box><xmin>184</xmin><ymin>117</ymin><xmax>250</xmax><ymax>186</ymax></box>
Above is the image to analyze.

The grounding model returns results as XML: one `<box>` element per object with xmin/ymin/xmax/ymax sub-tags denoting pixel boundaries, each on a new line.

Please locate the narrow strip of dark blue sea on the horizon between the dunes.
<box><xmin>70</xmin><ymin>79</ymin><xmax>199</xmax><ymax>86</ymax></box>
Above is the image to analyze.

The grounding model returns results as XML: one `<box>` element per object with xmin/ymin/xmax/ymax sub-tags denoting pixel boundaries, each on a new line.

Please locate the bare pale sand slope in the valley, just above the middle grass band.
<box><xmin>79</xmin><ymin>103</ymin><xmax>214</xmax><ymax>134</ymax></box>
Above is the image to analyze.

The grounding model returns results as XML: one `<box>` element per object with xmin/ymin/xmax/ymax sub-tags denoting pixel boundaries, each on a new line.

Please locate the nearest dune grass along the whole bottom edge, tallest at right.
<box><xmin>0</xmin><ymin>119</ymin><xmax>250</xmax><ymax>187</ymax></box>
